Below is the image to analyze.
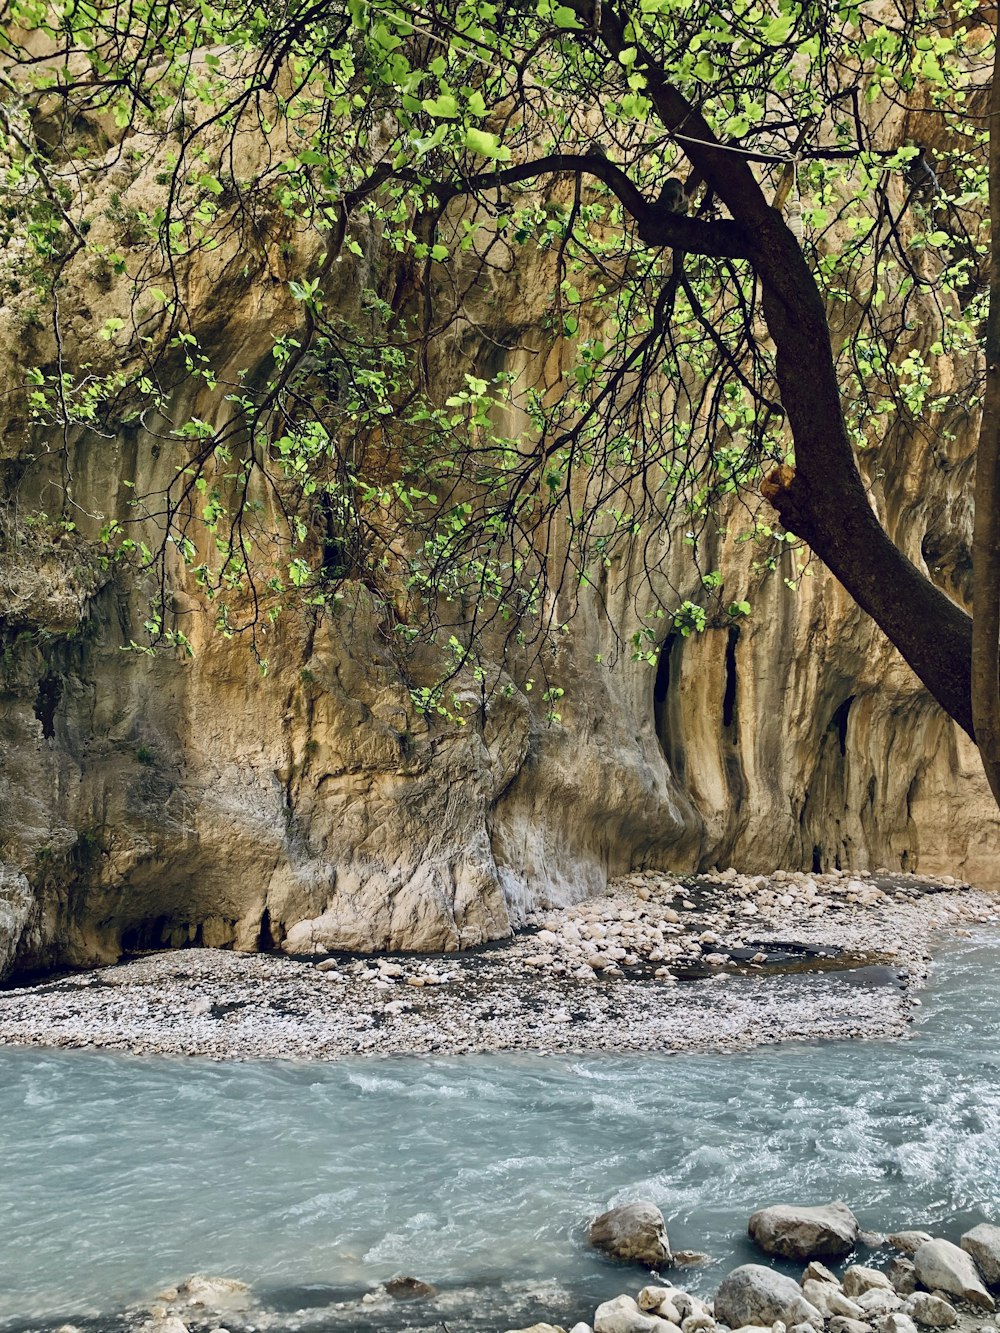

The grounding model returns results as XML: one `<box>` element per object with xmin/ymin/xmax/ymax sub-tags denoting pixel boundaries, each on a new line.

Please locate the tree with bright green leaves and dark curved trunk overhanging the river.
<box><xmin>0</xmin><ymin>0</ymin><xmax>1000</xmax><ymax>778</ymax></box>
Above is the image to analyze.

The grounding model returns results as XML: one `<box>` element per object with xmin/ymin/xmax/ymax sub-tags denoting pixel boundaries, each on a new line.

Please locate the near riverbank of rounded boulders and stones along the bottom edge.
<box><xmin>27</xmin><ymin>1201</ymin><xmax>1000</xmax><ymax>1333</ymax></box>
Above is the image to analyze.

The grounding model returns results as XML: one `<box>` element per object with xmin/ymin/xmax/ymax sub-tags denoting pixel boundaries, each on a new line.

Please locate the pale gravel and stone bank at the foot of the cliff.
<box><xmin>0</xmin><ymin>870</ymin><xmax>1000</xmax><ymax>1060</ymax></box>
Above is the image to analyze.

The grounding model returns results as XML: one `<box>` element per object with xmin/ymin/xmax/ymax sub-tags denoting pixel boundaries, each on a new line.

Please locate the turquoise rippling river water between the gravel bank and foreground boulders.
<box><xmin>0</xmin><ymin>929</ymin><xmax>1000</xmax><ymax>1333</ymax></box>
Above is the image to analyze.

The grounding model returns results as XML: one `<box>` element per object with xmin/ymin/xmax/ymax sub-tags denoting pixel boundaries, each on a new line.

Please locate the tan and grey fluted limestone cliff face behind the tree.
<box><xmin>0</xmin><ymin>129</ymin><xmax>1000</xmax><ymax>974</ymax></box>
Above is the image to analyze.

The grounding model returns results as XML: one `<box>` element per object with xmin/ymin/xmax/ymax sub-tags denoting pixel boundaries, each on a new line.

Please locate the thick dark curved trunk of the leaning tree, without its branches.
<box><xmin>586</xmin><ymin>0</ymin><xmax>981</xmax><ymax>741</ymax></box>
